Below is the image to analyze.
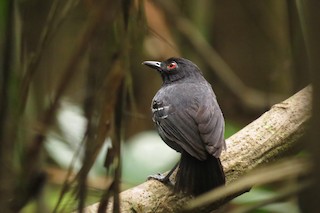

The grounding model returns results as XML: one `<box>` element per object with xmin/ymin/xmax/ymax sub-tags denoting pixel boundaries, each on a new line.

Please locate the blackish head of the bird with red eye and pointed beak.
<box><xmin>142</xmin><ymin>58</ymin><xmax>202</xmax><ymax>84</ymax></box>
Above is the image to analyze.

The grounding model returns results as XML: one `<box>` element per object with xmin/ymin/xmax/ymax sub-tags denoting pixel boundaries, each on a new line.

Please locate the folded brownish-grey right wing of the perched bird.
<box><xmin>195</xmin><ymin>99</ymin><xmax>226</xmax><ymax>158</ymax></box>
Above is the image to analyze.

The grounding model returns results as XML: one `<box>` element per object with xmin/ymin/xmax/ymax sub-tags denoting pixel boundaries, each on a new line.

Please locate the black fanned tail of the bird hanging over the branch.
<box><xmin>174</xmin><ymin>152</ymin><xmax>226</xmax><ymax>196</ymax></box>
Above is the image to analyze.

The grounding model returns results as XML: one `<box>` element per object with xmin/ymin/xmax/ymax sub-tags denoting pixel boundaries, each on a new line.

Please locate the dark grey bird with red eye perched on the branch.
<box><xmin>143</xmin><ymin>58</ymin><xmax>226</xmax><ymax>196</ymax></box>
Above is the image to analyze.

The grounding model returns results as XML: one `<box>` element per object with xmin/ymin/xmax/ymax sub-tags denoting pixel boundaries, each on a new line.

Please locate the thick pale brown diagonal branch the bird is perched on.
<box><xmin>85</xmin><ymin>86</ymin><xmax>312</xmax><ymax>213</ymax></box>
